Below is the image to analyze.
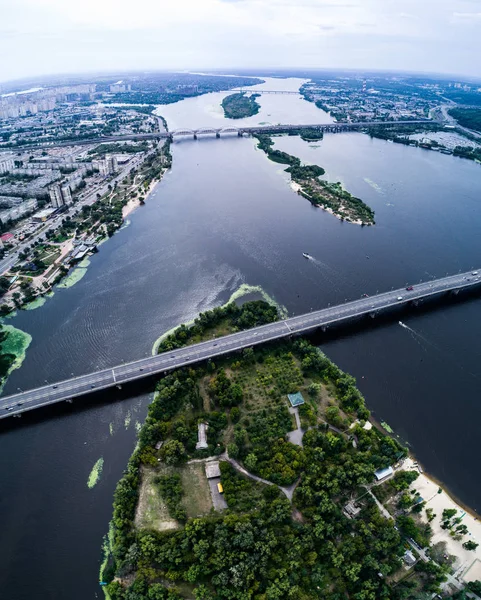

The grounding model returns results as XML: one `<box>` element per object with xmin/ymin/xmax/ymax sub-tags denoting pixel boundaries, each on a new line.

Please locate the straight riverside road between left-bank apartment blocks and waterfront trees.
<box><xmin>0</xmin><ymin>145</ymin><xmax>159</xmax><ymax>275</ymax></box>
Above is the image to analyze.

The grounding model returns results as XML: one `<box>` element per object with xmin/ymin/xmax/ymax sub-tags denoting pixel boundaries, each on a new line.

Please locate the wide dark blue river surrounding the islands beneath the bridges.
<box><xmin>0</xmin><ymin>79</ymin><xmax>481</xmax><ymax>600</ymax></box>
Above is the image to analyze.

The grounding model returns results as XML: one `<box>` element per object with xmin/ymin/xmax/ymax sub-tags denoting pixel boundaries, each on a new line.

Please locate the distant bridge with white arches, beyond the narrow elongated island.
<box><xmin>2</xmin><ymin>119</ymin><xmax>433</xmax><ymax>151</ymax></box>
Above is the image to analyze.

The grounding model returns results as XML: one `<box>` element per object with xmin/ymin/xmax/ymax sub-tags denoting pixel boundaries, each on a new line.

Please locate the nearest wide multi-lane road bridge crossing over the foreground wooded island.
<box><xmin>0</xmin><ymin>271</ymin><xmax>481</xmax><ymax>419</ymax></box>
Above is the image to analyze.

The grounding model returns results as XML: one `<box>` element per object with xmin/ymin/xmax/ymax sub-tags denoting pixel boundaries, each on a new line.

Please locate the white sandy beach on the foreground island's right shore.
<box><xmin>404</xmin><ymin>459</ymin><xmax>481</xmax><ymax>581</ymax></box>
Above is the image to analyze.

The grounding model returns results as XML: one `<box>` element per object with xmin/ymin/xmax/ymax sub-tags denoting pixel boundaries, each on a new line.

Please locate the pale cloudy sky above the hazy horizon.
<box><xmin>0</xmin><ymin>0</ymin><xmax>481</xmax><ymax>81</ymax></box>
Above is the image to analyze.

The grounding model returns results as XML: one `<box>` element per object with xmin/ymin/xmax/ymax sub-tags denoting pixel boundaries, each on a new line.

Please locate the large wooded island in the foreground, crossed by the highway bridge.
<box><xmin>100</xmin><ymin>301</ymin><xmax>481</xmax><ymax>600</ymax></box>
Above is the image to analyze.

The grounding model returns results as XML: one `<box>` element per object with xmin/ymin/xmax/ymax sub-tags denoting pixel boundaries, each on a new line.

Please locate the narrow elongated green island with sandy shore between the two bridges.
<box><xmin>255</xmin><ymin>134</ymin><xmax>375</xmax><ymax>225</ymax></box>
